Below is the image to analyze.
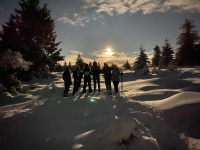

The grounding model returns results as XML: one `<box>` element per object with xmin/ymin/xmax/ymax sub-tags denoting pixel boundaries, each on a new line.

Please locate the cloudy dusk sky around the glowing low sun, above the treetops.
<box><xmin>0</xmin><ymin>0</ymin><xmax>200</xmax><ymax>65</ymax></box>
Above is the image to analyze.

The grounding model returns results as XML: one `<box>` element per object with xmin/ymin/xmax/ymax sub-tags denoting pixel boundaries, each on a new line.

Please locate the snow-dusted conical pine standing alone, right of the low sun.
<box><xmin>133</xmin><ymin>45</ymin><xmax>150</xmax><ymax>70</ymax></box>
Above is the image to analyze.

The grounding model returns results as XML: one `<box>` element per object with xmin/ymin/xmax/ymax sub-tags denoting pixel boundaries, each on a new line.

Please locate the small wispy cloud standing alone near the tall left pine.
<box><xmin>58</xmin><ymin>13</ymin><xmax>89</xmax><ymax>27</ymax></box>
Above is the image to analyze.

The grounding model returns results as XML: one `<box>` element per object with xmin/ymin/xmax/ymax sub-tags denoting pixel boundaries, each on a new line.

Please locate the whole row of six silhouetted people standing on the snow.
<box><xmin>63</xmin><ymin>61</ymin><xmax>123</xmax><ymax>97</ymax></box>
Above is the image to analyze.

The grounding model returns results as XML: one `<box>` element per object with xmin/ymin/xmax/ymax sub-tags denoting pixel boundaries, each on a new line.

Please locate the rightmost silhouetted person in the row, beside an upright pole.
<box><xmin>112</xmin><ymin>65</ymin><xmax>123</xmax><ymax>93</ymax></box>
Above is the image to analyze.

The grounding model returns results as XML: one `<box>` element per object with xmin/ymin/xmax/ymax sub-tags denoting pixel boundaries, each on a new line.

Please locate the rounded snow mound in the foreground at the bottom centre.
<box><xmin>75</xmin><ymin>118</ymin><xmax>136</xmax><ymax>150</ymax></box>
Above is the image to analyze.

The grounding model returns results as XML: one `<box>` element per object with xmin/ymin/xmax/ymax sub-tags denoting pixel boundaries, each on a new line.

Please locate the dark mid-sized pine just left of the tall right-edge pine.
<box><xmin>159</xmin><ymin>38</ymin><xmax>174</xmax><ymax>68</ymax></box>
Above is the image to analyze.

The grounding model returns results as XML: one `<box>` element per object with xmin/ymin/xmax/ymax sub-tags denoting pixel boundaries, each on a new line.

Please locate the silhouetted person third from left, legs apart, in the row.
<box><xmin>83</xmin><ymin>64</ymin><xmax>92</xmax><ymax>93</ymax></box>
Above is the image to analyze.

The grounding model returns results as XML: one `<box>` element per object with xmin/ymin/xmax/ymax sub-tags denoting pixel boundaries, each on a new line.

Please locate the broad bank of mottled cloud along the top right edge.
<box><xmin>82</xmin><ymin>0</ymin><xmax>200</xmax><ymax>16</ymax></box>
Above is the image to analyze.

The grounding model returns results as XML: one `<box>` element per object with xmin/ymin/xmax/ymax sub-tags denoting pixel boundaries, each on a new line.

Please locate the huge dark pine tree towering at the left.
<box><xmin>0</xmin><ymin>0</ymin><xmax>63</xmax><ymax>72</ymax></box>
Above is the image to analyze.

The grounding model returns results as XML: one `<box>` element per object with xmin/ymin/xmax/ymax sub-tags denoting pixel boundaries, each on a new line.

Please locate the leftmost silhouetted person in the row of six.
<box><xmin>63</xmin><ymin>67</ymin><xmax>72</xmax><ymax>97</ymax></box>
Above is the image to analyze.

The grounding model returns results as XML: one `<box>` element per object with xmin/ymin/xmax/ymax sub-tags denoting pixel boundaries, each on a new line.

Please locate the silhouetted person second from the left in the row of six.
<box><xmin>73</xmin><ymin>66</ymin><xmax>82</xmax><ymax>95</ymax></box>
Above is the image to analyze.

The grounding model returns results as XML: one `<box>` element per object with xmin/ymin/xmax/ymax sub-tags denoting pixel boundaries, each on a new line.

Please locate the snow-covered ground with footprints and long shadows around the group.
<box><xmin>0</xmin><ymin>68</ymin><xmax>200</xmax><ymax>150</ymax></box>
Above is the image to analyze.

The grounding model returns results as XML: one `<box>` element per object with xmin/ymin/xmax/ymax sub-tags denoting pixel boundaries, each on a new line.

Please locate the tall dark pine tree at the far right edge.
<box><xmin>175</xmin><ymin>19</ymin><xmax>200</xmax><ymax>66</ymax></box>
